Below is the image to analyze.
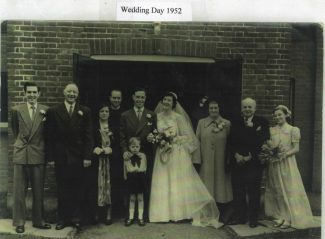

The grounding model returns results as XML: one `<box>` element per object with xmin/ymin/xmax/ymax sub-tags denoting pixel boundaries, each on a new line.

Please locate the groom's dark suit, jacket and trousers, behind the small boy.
<box><xmin>120</xmin><ymin>108</ymin><xmax>157</xmax><ymax>218</ymax></box>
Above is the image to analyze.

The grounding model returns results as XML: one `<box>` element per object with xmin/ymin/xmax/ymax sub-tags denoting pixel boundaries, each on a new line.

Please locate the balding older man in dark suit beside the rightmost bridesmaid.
<box><xmin>230</xmin><ymin>98</ymin><xmax>270</xmax><ymax>228</ymax></box>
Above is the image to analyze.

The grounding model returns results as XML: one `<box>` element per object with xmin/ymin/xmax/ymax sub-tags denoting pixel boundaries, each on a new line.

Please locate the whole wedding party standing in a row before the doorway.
<box><xmin>11</xmin><ymin>82</ymin><xmax>313</xmax><ymax>233</ymax></box>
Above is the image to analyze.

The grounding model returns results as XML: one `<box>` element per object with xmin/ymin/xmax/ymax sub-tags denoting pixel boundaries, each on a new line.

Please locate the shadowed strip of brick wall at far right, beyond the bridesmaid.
<box><xmin>291</xmin><ymin>25</ymin><xmax>315</xmax><ymax>187</ymax></box>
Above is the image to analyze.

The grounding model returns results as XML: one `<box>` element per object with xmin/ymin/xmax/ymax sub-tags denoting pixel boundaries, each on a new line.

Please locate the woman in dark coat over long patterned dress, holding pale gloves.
<box><xmin>93</xmin><ymin>104</ymin><xmax>112</xmax><ymax>225</ymax></box>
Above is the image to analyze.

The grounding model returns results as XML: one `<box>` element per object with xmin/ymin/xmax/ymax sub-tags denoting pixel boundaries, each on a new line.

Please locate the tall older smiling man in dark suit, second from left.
<box><xmin>47</xmin><ymin>83</ymin><xmax>93</xmax><ymax>230</ymax></box>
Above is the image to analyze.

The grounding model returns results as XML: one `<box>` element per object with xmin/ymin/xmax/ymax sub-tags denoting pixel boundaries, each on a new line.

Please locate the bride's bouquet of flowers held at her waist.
<box><xmin>151</xmin><ymin>127</ymin><xmax>176</xmax><ymax>153</ymax></box>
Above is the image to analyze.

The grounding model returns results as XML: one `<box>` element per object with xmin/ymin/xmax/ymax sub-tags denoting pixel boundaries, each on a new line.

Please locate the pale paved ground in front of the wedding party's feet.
<box><xmin>0</xmin><ymin>217</ymin><xmax>321</xmax><ymax>239</ymax></box>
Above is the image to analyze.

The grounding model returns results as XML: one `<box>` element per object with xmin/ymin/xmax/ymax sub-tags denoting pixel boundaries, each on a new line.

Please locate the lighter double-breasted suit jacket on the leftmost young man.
<box><xmin>11</xmin><ymin>103</ymin><xmax>48</xmax><ymax>164</ymax></box>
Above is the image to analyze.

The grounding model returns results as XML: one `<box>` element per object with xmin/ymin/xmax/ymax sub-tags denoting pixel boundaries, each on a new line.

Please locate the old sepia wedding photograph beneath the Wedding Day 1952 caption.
<box><xmin>0</xmin><ymin>20</ymin><xmax>324</xmax><ymax>239</ymax></box>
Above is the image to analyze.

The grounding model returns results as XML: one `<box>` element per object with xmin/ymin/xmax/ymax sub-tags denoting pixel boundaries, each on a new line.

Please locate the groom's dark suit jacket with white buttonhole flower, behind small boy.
<box><xmin>120</xmin><ymin>108</ymin><xmax>157</xmax><ymax>153</ymax></box>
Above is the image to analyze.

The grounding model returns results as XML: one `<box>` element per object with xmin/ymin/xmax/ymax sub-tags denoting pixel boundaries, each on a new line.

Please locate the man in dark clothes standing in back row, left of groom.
<box><xmin>109</xmin><ymin>89</ymin><xmax>126</xmax><ymax>217</ymax></box>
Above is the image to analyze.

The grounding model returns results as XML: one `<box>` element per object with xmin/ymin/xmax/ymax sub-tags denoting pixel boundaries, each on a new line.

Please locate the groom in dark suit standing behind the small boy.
<box><xmin>120</xmin><ymin>88</ymin><xmax>157</xmax><ymax>221</ymax></box>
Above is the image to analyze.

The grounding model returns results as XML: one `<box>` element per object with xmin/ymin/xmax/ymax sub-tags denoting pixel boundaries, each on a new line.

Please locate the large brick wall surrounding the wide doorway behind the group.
<box><xmin>0</xmin><ymin>21</ymin><xmax>318</xmax><ymax>203</ymax></box>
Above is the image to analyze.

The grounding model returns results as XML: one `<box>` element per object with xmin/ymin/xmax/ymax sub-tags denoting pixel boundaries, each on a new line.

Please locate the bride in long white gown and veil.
<box><xmin>149</xmin><ymin>92</ymin><xmax>222</xmax><ymax>228</ymax></box>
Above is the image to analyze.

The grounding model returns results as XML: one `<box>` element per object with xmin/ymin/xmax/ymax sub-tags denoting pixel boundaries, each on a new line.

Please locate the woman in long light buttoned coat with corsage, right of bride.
<box><xmin>196</xmin><ymin>100</ymin><xmax>233</xmax><ymax>222</ymax></box>
